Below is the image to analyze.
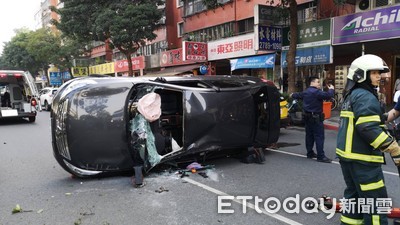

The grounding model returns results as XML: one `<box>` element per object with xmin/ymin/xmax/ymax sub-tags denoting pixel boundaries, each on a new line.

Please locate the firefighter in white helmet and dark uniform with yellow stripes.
<box><xmin>336</xmin><ymin>55</ymin><xmax>400</xmax><ymax>225</ymax></box>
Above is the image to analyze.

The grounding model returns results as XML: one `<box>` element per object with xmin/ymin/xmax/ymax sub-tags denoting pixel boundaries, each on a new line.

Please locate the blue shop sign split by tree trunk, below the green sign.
<box><xmin>281</xmin><ymin>45</ymin><xmax>333</xmax><ymax>67</ymax></box>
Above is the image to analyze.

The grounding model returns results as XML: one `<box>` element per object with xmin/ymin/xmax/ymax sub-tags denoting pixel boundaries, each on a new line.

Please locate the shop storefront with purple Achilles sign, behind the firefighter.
<box><xmin>330</xmin><ymin>5</ymin><xmax>400</xmax><ymax>104</ymax></box>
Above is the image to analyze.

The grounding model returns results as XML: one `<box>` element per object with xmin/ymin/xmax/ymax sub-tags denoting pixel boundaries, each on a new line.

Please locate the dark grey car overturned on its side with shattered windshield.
<box><xmin>51</xmin><ymin>76</ymin><xmax>280</xmax><ymax>177</ymax></box>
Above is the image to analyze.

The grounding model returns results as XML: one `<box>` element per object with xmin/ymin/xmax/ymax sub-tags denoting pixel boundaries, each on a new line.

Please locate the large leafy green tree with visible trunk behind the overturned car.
<box><xmin>52</xmin><ymin>0</ymin><xmax>163</xmax><ymax>76</ymax></box>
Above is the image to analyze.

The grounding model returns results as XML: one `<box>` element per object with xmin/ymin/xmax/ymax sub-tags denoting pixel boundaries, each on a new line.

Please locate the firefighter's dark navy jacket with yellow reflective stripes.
<box><xmin>336</xmin><ymin>88</ymin><xmax>393</xmax><ymax>164</ymax></box>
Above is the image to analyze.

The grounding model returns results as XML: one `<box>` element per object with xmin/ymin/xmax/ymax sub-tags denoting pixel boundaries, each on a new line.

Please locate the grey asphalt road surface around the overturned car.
<box><xmin>0</xmin><ymin>111</ymin><xmax>400</xmax><ymax>225</ymax></box>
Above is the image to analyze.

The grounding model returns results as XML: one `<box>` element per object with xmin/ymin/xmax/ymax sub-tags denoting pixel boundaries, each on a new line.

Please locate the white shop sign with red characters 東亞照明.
<box><xmin>208</xmin><ymin>33</ymin><xmax>256</xmax><ymax>61</ymax></box>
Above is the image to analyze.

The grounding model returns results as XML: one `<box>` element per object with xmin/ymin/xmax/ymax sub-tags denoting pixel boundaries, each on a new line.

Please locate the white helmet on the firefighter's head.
<box><xmin>347</xmin><ymin>54</ymin><xmax>390</xmax><ymax>83</ymax></box>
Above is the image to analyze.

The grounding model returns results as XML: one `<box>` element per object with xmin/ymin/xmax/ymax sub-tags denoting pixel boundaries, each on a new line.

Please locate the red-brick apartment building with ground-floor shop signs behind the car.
<box><xmin>38</xmin><ymin>0</ymin><xmax>400</xmax><ymax>103</ymax></box>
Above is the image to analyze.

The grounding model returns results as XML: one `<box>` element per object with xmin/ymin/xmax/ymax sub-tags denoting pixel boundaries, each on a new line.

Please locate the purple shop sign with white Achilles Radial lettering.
<box><xmin>332</xmin><ymin>5</ymin><xmax>400</xmax><ymax>45</ymax></box>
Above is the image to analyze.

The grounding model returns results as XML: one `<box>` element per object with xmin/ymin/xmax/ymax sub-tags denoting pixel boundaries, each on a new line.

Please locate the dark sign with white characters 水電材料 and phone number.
<box><xmin>255</xmin><ymin>25</ymin><xmax>282</xmax><ymax>51</ymax></box>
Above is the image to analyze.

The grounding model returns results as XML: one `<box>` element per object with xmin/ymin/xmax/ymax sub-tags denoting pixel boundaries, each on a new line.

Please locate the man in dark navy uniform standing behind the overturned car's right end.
<box><xmin>291</xmin><ymin>77</ymin><xmax>334</xmax><ymax>163</ymax></box>
